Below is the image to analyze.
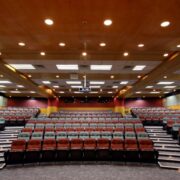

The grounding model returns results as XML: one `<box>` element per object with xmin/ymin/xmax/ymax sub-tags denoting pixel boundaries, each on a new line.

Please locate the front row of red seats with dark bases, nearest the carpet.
<box><xmin>6</xmin><ymin>138</ymin><xmax>157</xmax><ymax>163</ymax></box>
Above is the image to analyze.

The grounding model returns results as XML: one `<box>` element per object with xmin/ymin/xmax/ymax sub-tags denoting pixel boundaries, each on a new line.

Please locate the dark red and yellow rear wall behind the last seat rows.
<box><xmin>7</xmin><ymin>98</ymin><xmax>163</xmax><ymax>114</ymax></box>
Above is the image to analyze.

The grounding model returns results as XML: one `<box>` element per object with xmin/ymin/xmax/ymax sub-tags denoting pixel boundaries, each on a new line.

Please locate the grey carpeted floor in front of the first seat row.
<box><xmin>0</xmin><ymin>164</ymin><xmax>180</xmax><ymax>180</ymax></box>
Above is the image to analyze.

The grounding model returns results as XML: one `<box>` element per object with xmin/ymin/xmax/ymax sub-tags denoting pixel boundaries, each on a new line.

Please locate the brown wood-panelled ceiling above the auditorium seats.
<box><xmin>0</xmin><ymin>0</ymin><xmax>180</xmax><ymax>97</ymax></box>
